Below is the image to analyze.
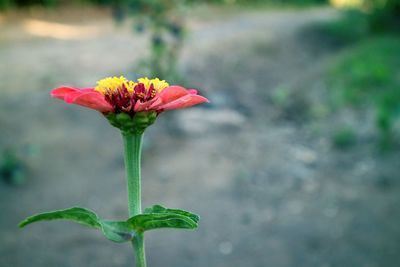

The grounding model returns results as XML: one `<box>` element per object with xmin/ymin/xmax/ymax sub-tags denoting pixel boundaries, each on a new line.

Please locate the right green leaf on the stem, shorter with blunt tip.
<box><xmin>128</xmin><ymin>205</ymin><xmax>199</xmax><ymax>232</ymax></box>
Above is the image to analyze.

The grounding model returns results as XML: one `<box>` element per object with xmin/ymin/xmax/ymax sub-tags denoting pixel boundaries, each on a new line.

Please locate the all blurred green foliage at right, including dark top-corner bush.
<box><xmin>316</xmin><ymin>0</ymin><xmax>400</xmax><ymax>149</ymax></box>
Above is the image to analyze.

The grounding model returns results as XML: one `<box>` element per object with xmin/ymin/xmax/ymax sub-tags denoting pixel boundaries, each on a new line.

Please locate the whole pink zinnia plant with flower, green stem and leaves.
<box><xmin>19</xmin><ymin>76</ymin><xmax>208</xmax><ymax>267</ymax></box>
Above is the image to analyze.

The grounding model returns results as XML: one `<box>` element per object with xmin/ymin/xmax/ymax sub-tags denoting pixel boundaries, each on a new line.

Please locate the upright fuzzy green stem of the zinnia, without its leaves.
<box><xmin>122</xmin><ymin>133</ymin><xmax>146</xmax><ymax>267</ymax></box>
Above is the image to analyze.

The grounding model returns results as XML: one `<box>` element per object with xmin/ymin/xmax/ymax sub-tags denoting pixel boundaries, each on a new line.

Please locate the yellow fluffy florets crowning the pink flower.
<box><xmin>94</xmin><ymin>76</ymin><xmax>169</xmax><ymax>95</ymax></box>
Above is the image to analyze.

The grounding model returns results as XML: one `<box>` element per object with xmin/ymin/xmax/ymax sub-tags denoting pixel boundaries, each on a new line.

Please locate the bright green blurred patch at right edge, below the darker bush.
<box><xmin>329</xmin><ymin>35</ymin><xmax>400</xmax><ymax>149</ymax></box>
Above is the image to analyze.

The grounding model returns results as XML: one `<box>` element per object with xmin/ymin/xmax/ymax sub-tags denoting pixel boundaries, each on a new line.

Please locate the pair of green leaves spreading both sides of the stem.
<box><xmin>19</xmin><ymin>205</ymin><xmax>199</xmax><ymax>242</ymax></box>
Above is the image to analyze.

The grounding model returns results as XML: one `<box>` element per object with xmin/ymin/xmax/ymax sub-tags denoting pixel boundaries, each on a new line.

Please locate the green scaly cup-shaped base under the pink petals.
<box><xmin>104</xmin><ymin>111</ymin><xmax>157</xmax><ymax>134</ymax></box>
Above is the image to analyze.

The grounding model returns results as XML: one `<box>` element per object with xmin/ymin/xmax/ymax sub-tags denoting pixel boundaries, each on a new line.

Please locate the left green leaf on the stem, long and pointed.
<box><xmin>19</xmin><ymin>207</ymin><xmax>135</xmax><ymax>242</ymax></box>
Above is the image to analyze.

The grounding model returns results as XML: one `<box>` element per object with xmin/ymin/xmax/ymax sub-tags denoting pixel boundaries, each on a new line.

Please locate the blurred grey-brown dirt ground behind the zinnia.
<box><xmin>0</xmin><ymin>5</ymin><xmax>400</xmax><ymax>267</ymax></box>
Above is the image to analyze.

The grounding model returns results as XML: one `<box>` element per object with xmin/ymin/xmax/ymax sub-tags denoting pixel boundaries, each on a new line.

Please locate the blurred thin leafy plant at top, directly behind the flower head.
<box><xmin>113</xmin><ymin>0</ymin><xmax>186</xmax><ymax>83</ymax></box>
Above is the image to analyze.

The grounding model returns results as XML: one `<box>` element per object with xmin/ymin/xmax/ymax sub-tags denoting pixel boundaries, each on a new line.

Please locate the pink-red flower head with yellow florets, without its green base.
<box><xmin>51</xmin><ymin>76</ymin><xmax>208</xmax><ymax>115</ymax></box>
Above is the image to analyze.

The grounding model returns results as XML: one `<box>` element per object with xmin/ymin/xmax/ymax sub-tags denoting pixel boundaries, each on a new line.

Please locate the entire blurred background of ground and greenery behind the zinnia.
<box><xmin>0</xmin><ymin>0</ymin><xmax>400</xmax><ymax>267</ymax></box>
